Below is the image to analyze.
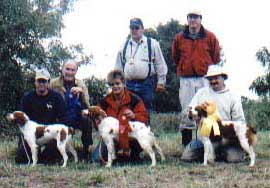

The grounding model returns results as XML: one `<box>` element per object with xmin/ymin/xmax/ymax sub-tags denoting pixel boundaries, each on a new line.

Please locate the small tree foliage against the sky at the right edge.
<box><xmin>249</xmin><ymin>47</ymin><xmax>270</xmax><ymax>99</ymax></box>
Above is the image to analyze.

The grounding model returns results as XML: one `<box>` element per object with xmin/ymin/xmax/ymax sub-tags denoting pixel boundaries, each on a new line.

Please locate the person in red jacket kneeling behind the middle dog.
<box><xmin>99</xmin><ymin>70</ymin><xmax>149</xmax><ymax>160</ymax></box>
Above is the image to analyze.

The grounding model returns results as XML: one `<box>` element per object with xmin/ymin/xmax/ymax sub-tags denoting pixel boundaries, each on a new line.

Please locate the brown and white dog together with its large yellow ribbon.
<box><xmin>188</xmin><ymin>101</ymin><xmax>257</xmax><ymax>166</ymax></box>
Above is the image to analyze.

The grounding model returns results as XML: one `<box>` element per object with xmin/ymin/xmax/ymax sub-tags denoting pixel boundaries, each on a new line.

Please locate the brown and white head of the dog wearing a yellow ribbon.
<box><xmin>188</xmin><ymin>101</ymin><xmax>217</xmax><ymax>120</ymax></box>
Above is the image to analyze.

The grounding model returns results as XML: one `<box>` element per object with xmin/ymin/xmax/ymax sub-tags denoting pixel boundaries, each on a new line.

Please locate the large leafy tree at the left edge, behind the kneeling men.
<box><xmin>0</xmin><ymin>0</ymin><xmax>91</xmax><ymax>135</ymax></box>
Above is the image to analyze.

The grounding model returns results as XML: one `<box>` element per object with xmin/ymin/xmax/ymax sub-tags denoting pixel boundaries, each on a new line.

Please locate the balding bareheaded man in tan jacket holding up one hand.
<box><xmin>50</xmin><ymin>61</ymin><xmax>93</xmax><ymax>160</ymax></box>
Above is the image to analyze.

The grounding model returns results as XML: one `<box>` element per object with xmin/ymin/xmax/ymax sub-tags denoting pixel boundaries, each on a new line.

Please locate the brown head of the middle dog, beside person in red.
<box><xmin>82</xmin><ymin>106</ymin><xmax>107</xmax><ymax>128</ymax></box>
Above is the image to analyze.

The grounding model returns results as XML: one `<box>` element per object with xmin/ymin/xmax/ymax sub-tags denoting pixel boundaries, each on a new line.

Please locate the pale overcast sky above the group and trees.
<box><xmin>62</xmin><ymin>0</ymin><xmax>270</xmax><ymax>98</ymax></box>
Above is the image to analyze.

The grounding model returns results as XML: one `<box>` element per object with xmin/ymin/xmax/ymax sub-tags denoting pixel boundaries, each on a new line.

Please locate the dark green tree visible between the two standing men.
<box><xmin>145</xmin><ymin>19</ymin><xmax>184</xmax><ymax>112</ymax></box>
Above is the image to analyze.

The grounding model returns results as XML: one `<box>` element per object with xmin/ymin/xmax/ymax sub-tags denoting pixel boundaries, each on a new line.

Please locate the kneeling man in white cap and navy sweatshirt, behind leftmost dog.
<box><xmin>15</xmin><ymin>69</ymin><xmax>66</xmax><ymax>163</ymax></box>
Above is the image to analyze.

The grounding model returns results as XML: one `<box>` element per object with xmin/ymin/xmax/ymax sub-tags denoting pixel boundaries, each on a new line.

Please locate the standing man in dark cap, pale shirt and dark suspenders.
<box><xmin>115</xmin><ymin>18</ymin><xmax>168</xmax><ymax>112</ymax></box>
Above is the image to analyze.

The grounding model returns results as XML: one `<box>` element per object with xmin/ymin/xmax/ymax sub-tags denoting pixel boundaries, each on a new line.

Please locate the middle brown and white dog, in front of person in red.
<box><xmin>83</xmin><ymin>106</ymin><xmax>165</xmax><ymax>167</ymax></box>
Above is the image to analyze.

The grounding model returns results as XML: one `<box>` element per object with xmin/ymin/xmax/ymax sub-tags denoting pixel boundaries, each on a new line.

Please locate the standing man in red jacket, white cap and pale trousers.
<box><xmin>172</xmin><ymin>11</ymin><xmax>220</xmax><ymax>146</ymax></box>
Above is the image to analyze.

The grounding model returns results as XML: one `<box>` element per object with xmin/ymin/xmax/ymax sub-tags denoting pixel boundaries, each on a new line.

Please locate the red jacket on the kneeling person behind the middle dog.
<box><xmin>99</xmin><ymin>89</ymin><xmax>149</xmax><ymax>123</ymax></box>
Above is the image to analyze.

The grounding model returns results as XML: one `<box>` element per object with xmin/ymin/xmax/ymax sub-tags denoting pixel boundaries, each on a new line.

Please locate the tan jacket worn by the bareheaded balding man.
<box><xmin>50</xmin><ymin>76</ymin><xmax>90</xmax><ymax>108</ymax></box>
